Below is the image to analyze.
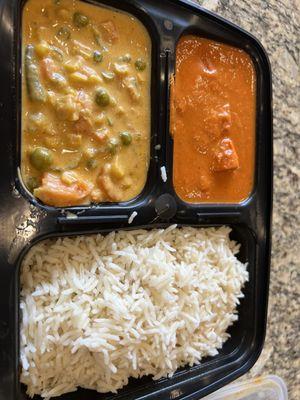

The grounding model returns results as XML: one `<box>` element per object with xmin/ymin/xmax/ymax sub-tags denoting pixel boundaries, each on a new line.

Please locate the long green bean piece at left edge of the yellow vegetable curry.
<box><xmin>25</xmin><ymin>44</ymin><xmax>46</xmax><ymax>103</ymax></box>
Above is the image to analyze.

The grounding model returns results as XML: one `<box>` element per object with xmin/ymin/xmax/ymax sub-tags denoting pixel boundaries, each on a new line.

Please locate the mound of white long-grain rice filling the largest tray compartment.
<box><xmin>20</xmin><ymin>226</ymin><xmax>248</xmax><ymax>399</ymax></box>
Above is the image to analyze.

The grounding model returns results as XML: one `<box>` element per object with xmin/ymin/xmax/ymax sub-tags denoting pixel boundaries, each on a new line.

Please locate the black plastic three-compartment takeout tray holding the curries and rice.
<box><xmin>0</xmin><ymin>0</ymin><xmax>272</xmax><ymax>400</ymax></box>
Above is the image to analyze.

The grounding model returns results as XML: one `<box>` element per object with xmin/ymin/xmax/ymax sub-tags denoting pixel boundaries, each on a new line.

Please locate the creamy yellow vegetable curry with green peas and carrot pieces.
<box><xmin>21</xmin><ymin>0</ymin><xmax>151</xmax><ymax>206</ymax></box>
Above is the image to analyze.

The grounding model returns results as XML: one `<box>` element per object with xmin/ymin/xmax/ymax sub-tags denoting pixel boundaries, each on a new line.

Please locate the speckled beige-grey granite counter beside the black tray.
<box><xmin>191</xmin><ymin>0</ymin><xmax>300</xmax><ymax>400</ymax></box>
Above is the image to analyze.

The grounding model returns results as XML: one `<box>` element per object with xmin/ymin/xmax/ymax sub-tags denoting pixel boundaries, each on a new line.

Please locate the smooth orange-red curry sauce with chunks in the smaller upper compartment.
<box><xmin>171</xmin><ymin>35</ymin><xmax>256</xmax><ymax>203</ymax></box>
